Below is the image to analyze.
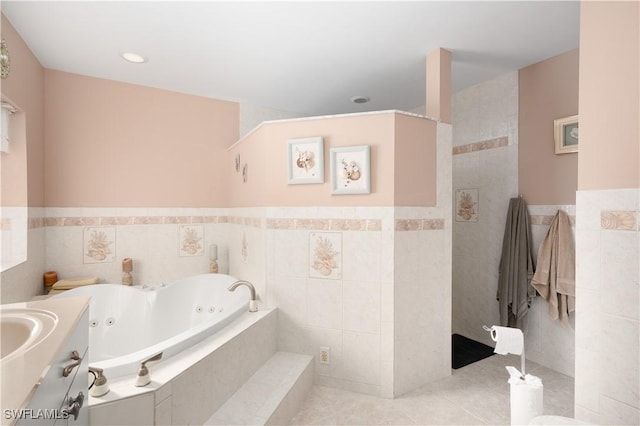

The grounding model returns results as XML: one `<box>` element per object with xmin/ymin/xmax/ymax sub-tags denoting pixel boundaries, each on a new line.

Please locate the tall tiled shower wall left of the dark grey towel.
<box><xmin>452</xmin><ymin>72</ymin><xmax>518</xmax><ymax>346</ymax></box>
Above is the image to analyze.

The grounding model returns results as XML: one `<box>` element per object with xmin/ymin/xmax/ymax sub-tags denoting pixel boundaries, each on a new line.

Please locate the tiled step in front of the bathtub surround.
<box><xmin>205</xmin><ymin>352</ymin><xmax>313</xmax><ymax>425</ymax></box>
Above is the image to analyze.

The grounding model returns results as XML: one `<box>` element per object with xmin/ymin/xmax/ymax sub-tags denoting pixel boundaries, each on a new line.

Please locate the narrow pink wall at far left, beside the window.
<box><xmin>1</xmin><ymin>15</ymin><xmax>44</xmax><ymax>207</ymax></box>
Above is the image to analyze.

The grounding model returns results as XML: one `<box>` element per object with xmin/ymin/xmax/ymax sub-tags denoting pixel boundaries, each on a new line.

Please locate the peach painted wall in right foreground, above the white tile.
<box><xmin>578</xmin><ymin>1</ymin><xmax>640</xmax><ymax>190</ymax></box>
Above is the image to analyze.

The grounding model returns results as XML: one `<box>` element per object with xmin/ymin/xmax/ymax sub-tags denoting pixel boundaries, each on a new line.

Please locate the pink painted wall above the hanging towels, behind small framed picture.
<box><xmin>518</xmin><ymin>49</ymin><xmax>581</xmax><ymax>204</ymax></box>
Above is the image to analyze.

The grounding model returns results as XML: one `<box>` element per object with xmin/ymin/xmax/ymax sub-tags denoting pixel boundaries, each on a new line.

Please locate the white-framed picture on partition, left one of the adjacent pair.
<box><xmin>287</xmin><ymin>136</ymin><xmax>324</xmax><ymax>185</ymax></box>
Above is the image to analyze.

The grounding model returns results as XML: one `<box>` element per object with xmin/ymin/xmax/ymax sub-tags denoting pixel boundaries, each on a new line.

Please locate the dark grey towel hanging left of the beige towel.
<box><xmin>496</xmin><ymin>197</ymin><xmax>536</xmax><ymax>330</ymax></box>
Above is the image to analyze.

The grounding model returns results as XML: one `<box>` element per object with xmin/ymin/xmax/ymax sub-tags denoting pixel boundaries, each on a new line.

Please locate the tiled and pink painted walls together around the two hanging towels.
<box><xmin>452</xmin><ymin>51</ymin><xmax>578</xmax><ymax>377</ymax></box>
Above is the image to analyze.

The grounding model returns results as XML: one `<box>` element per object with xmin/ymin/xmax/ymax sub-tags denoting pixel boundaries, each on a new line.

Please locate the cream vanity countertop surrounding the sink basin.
<box><xmin>0</xmin><ymin>297</ymin><xmax>90</xmax><ymax>424</ymax></box>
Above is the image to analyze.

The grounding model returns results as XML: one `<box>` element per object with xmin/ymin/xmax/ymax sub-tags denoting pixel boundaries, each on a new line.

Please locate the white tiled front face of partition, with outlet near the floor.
<box><xmin>266</xmin><ymin>207</ymin><xmax>394</xmax><ymax>395</ymax></box>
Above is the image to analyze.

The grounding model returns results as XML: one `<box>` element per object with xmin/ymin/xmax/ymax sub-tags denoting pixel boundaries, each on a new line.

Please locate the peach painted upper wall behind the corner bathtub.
<box><xmin>45</xmin><ymin>70</ymin><xmax>238</xmax><ymax>207</ymax></box>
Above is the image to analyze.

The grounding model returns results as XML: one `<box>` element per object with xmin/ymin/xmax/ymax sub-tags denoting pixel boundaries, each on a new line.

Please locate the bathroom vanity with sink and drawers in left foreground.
<box><xmin>0</xmin><ymin>297</ymin><xmax>89</xmax><ymax>425</ymax></box>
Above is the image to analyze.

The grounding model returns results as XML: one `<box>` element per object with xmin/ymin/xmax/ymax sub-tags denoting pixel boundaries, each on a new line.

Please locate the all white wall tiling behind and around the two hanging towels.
<box><xmin>452</xmin><ymin>73</ymin><xmax>575</xmax><ymax>376</ymax></box>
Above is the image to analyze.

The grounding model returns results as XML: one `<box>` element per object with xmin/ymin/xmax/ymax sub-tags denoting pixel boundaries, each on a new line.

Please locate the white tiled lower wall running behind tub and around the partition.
<box><xmin>10</xmin><ymin>201</ymin><xmax>450</xmax><ymax>397</ymax></box>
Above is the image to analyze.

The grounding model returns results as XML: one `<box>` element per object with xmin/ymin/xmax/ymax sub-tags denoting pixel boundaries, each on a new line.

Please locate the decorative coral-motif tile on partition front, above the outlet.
<box><xmin>309</xmin><ymin>232</ymin><xmax>342</xmax><ymax>280</ymax></box>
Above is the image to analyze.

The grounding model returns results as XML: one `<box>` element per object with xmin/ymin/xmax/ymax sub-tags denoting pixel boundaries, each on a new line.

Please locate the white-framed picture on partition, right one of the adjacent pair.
<box><xmin>331</xmin><ymin>145</ymin><xmax>371</xmax><ymax>195</ymax></box>
